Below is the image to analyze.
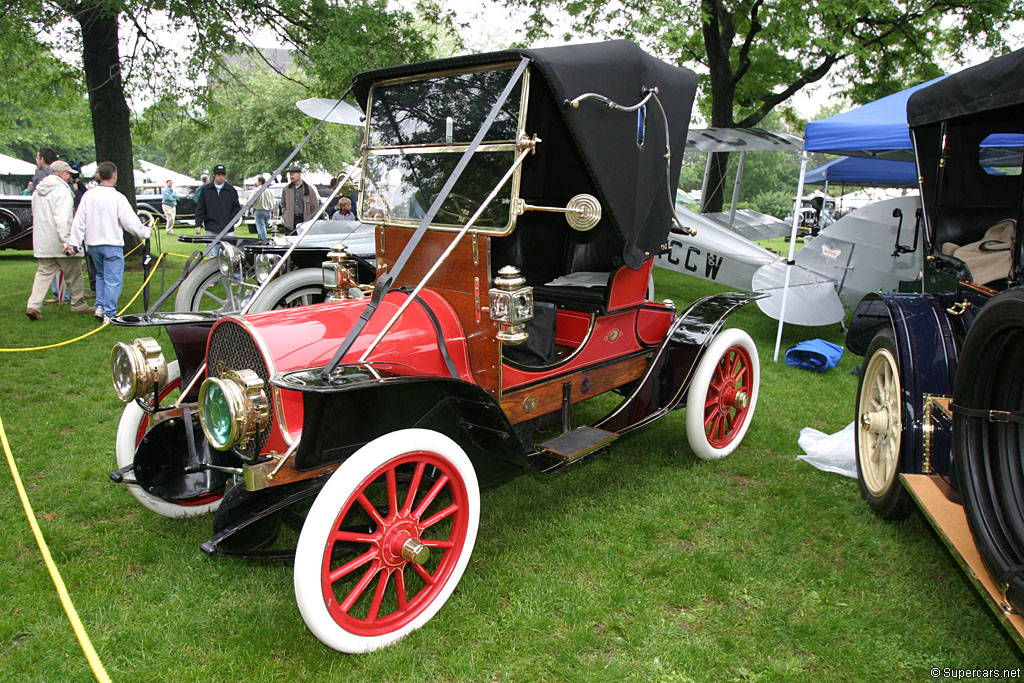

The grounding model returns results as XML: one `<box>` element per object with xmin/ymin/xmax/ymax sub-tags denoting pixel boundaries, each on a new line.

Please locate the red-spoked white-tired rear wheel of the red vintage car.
<box><xmin>686</xmin><ymin>328</ymin><xmax>761</xmax><ymax>460</ymax></box>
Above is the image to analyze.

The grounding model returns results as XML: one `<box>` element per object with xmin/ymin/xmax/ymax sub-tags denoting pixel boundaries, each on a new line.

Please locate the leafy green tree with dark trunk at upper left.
<box><xmin>0</xmin><ymin>0</ymin><xmax>448</xmax><ymax>224</ymax></box>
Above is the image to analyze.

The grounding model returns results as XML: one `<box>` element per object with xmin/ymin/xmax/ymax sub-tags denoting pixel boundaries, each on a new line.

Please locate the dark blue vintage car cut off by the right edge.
<box><xmin>847</xmin><ymin>50</ymin><xmax>1024</xmax><ymax>643</ymax></box>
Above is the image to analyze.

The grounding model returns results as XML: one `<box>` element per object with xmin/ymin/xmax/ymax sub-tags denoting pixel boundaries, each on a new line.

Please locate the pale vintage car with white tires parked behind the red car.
<box><xmin>174</xmin><ymin>220</ymin><xmax>377</xmax><ymax>314</ymax></box>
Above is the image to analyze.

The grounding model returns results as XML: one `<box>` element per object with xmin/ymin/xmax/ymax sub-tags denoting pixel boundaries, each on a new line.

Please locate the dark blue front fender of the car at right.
<box><xmin>847</xmin><ymin>293</ymin><xmax>962</xmax><ymax>481</ymax></box>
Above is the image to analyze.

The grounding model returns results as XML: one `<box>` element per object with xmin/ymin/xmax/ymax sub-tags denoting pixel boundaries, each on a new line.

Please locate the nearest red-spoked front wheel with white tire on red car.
<box><xmin>295</xmin><ymin>429</ymin><xmax>480</xmax><ymax>652</ymax></box>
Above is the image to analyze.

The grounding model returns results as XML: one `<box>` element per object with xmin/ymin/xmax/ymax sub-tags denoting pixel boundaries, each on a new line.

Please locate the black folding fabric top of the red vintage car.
<box><xmin>354</xmin><ymin>40</ymin><xmax>696</xmax><ymax>268</ymax></box>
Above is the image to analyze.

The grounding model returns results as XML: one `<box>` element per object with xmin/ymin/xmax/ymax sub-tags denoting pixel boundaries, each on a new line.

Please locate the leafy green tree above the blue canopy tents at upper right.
<box><xmin>505</xmin><ymin>0</ymin><xmax>1024</xmax><ymax>210</ymax></box>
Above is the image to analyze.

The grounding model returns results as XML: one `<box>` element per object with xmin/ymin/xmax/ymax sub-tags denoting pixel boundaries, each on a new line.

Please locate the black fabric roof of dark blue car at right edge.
<box><xmin>906</xmin><ymin>49</ymin><xmax>1024</xmax><ymax>128</ymax></box>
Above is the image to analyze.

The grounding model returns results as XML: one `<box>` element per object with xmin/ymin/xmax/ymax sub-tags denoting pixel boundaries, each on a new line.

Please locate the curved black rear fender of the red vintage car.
<box><xmin>595</xmin><ymin>292</ymin><xmax>767</xmax><ymax>434</ymax></box>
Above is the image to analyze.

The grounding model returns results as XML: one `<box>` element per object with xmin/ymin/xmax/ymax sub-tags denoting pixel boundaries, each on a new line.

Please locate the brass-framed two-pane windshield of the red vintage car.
<box><xmin>359</xmin><ymin>65</ymin><xmax>527</xmax><ymax>232</ymax></box>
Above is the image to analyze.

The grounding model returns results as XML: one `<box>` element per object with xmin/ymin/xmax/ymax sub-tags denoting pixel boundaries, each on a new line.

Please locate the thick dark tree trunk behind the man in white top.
<box><xmin>75</xmin><ymin>0</ymin><xmax>139</xmax><ymax>250</ymax></box>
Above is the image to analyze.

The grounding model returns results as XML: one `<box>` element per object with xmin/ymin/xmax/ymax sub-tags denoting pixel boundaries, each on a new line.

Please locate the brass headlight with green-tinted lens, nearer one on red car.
<box><xmin>199</xmin><ymin>370</ymin><xmax>270</xmax><ymax>451</ymax></box>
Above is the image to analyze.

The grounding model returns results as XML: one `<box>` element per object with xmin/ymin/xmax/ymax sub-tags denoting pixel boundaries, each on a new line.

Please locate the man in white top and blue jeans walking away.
<box><xmin>70</xmin><ymin>161</ymin><xmax>150</xmax><ymax>323</ymax></box>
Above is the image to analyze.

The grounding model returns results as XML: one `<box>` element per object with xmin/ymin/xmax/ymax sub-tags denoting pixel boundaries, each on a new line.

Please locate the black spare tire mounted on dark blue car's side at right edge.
<box><xmin>953</xmin><ymin>288</ymin><xmax>1024</xmax><ymax>611</ymax></box>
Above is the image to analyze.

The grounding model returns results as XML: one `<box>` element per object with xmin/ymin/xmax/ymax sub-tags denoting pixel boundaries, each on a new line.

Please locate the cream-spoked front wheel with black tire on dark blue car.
<box><xmin>854</xmin><ymin>327</ymin><xmax>913</xmax><ymax>521</ymax></box>
